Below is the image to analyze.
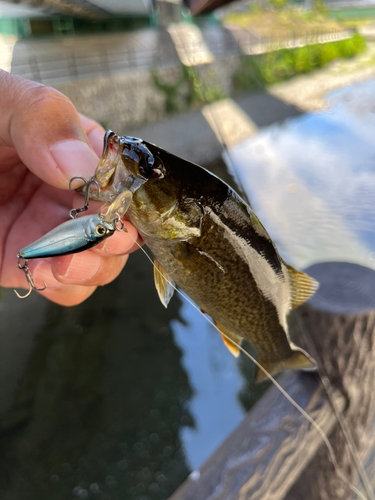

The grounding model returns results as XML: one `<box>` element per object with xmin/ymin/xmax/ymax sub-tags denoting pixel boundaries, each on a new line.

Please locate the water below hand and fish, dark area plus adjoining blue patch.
<box><xmin>0</xmin><ymin>244</ymin><xmax>260</xmax><ymax>500</ymax></box>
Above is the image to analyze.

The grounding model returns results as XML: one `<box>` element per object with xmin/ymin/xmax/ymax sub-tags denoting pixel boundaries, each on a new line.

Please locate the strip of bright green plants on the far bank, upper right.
<box><xmin>233</xmin><ymin>34</ymin><xmax>366</xmax><ymax>90</ymax></box>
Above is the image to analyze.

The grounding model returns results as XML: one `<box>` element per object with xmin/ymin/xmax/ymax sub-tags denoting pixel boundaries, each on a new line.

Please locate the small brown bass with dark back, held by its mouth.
<box><xmin>86</xmin><ymin>131</ymin><xmax>318</xmax><ymax>381</ymax></box>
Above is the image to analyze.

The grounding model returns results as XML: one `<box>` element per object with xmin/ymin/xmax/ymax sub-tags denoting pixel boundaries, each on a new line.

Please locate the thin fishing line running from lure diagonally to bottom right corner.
<box><xmin>128</xmin><ymin>233</ymin><xmax>373</xmax><ymax>500</ymax></box>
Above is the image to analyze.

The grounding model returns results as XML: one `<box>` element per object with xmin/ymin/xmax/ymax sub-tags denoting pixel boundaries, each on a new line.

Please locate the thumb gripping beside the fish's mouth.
<box><xmin>0</xmin><ymin>71</ymin><xmax>99</xmax><ymax>189</ymax></box>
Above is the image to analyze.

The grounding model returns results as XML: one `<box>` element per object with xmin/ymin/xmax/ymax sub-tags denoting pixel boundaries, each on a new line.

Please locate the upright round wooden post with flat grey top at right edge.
<box><xmin>286</xmin><ymin>263</ymin><xmax>375</xmax><ymax>500</ymax></box>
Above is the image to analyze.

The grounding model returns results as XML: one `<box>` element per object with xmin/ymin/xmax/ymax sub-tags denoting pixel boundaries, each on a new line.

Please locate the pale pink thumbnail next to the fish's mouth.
<box><xmin>50</xmin><ymin>139</ymin><xmax>99</xmax><ymax>180</ymax></box>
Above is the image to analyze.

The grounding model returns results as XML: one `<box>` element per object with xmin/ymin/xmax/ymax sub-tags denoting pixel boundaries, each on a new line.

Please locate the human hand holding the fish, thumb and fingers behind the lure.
<box><xmin>0</xmin><ymin>70</ymin><xmax>139</xmax><ymax>306</ymax></box>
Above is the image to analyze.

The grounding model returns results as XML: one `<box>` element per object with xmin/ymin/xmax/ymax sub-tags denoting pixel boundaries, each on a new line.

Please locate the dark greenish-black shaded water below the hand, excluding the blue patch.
<box><xmin>0</xmin><ymin>254</ymin><xmax>194</xmax><ymax>500</ymax></box>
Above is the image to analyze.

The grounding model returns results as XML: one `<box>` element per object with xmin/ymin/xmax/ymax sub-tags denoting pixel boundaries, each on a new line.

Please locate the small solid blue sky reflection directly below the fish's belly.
<box><xmin>173</xmin><ymin>304</ymin><xmax>243</xmax><ymax>469</ymax></box>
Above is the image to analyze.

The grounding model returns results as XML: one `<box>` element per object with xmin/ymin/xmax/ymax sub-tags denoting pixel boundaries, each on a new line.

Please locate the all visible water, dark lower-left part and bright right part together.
<box><xmin>0</xmin><ymin>82</ymin><xmax>375</xmax><ymax>500</ymax></box>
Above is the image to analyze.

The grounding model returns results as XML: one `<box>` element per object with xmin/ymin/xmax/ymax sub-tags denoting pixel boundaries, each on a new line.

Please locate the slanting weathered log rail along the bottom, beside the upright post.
<box><xmin>171</xmin><ymin>372</ymin><xmax>345</xmax><ymax>500</ymax></box>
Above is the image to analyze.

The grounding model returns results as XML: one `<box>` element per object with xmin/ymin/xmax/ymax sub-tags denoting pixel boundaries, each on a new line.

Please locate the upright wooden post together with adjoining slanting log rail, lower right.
<box><xmin>170</xmin><ymin>263</ymin><xmax>375</xmax><ymax>500</ymax></box>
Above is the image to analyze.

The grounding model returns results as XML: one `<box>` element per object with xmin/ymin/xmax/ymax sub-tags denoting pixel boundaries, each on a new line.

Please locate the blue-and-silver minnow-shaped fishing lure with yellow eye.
<box><xmin>19</xmin><ymin>215</ymin><xmax>116</xmax><ymax>259</ymax></box>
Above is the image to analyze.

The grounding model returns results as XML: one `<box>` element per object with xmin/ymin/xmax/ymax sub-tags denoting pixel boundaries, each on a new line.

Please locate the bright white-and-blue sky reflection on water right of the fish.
<box><xmin>230</xmin><ymin>81</ymin><xmax>375</xmax><ymax>268</ymax></box>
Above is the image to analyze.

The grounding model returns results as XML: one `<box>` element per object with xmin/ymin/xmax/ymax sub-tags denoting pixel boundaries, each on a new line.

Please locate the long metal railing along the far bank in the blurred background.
<box><xmin>11</xmin><ymin>28</ymin><xmax>352</xmax><ymax>85</ymax></box>
